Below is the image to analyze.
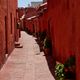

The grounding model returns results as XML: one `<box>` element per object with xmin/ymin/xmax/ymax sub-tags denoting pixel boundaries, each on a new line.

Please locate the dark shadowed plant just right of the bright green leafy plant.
<box><xmin>64</xmin><ymin>56</ymin><xmax>76</xmax><ymax>80</ymax></box>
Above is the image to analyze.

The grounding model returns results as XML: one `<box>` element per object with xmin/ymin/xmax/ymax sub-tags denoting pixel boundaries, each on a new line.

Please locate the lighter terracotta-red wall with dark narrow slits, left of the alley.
<box><xmin>0</xmin><ymin>0</ymin><xmax>17</xmax><ymax>67</ymax></box>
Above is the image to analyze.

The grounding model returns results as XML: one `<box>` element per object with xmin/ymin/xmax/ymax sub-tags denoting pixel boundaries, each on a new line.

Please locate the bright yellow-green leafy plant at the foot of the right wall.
<box><xmin>55</xmin><ymin>63</ymin><xmax>64</xmax><ymax>80</ymax></box>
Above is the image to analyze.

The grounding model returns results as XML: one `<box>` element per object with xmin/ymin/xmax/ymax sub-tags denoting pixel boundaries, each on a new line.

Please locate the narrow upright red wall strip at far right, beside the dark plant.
<box><xmin>74</xmin><ymin>0</ymin><xmax>80</xmax><ymax>80</ymax></box>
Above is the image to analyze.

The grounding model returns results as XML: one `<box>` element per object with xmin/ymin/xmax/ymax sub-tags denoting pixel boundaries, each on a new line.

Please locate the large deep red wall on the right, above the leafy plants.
<box><xmin>48</xmin><ymin>0</ymin><xmax>75</xmax><ymax>62</ymax></box>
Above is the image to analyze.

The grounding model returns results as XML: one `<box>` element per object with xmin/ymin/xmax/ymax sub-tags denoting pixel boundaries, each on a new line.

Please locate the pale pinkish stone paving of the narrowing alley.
<box><xmin>0</xmin><ymin>32</ymin><xmax>55</xmax><ymax>80</ymax></box>
